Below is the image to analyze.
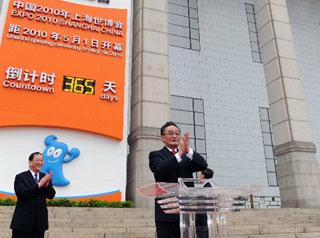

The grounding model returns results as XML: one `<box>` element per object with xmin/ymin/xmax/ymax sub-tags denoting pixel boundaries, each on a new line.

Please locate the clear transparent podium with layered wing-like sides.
<box><xmin>139</xmin><ymin>178</ymin><xmax>261</xmax><ymax>238</ymax></box>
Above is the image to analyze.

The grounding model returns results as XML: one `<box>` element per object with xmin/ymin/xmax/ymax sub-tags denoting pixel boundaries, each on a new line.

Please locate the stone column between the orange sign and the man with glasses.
<box><xmin>127</xmin><ymin>0</ymin><xmax>170</xmax><ymax>207</ymax></box>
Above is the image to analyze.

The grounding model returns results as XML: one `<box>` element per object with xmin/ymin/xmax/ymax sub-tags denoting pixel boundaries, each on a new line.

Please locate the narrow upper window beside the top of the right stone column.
<box><xmin>245</xmin><ymin>3</ymin><xmax>261</xmax><ymax>63</ymax></box>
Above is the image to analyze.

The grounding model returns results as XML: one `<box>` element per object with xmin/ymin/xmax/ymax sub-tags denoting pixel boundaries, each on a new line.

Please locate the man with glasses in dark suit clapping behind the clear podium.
<box><xmin>149</xmin><ymin>121</ymin><xmax>207</xmax><ymax>238</ymax></box>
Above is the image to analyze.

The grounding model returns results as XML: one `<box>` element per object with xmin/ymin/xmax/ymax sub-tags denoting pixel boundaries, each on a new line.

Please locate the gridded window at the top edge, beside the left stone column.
<box><xmin>168</xmin><ymin>0</ymin><xmax>200</xmax><ymax>51</ymax></box>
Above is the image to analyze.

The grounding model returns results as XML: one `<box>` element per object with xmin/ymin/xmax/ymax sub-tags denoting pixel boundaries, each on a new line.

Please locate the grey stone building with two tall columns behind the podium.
<box><xmin>127</xmin><ymin>0</ymin><xmax>320</xmax><ymax>207</ymax></box>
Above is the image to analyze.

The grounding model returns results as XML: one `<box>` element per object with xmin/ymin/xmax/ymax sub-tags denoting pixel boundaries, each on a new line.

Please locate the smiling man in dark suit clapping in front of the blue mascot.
<box><xmin>10</xmin><ymin>152</ymin><xmax>56</xmax><ymax>238</ymax></box>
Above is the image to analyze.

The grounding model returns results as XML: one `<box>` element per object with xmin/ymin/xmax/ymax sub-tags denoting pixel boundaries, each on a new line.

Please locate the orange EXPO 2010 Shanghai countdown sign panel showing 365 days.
<box><xmin>0</xmin><ymin>0</ymin><xmax>127</xmax><ymax>140</ymax></box>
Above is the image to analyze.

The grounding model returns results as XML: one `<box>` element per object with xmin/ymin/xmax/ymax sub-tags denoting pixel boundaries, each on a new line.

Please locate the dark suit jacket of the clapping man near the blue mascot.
<box><xmin>10</xmin><ymin>170</ymin><xmax>56</xmax><ymax>232</ymax></box>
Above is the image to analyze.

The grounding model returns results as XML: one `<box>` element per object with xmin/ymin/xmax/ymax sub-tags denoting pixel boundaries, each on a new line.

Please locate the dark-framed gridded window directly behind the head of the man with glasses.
<box><xmin>170</xmin><ymin>96</ymin><xmax>207</xmax><ymax>159</ymax></box>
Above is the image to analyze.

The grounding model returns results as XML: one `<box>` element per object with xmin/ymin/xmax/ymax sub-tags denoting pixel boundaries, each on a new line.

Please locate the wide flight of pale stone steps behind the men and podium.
<box><xmin>0</xmin><ymin>207</ymin><xmax>320</xmax><ymax>238</ymax></box>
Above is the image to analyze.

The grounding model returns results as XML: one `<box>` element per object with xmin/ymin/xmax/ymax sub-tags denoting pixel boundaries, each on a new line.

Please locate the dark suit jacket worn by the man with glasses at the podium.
<box><xmin>149</xmin><ymin>147</ymin><xmax>208</xmax><ymax>222</ymax></box>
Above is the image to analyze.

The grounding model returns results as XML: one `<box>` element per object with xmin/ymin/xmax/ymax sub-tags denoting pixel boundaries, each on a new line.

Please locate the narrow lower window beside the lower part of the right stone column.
<box><xmin>259</xmin><ymin>107</ymin><xmax>278</xmax><ymax>186</ymax></box>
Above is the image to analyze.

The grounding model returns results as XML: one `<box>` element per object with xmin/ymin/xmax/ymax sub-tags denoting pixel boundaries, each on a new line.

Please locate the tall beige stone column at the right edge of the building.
<box><xmin>255</xmin><ymin>0</ymin><xmax>320</xmax><ymax>207</ymax></box>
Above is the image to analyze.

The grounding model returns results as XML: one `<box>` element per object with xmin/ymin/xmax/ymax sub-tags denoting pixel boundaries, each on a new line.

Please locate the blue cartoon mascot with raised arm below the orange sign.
<box><xmin>41</xmin><ymin>135</ymin><xmax>80</xmax><ymax>186</ymax></box>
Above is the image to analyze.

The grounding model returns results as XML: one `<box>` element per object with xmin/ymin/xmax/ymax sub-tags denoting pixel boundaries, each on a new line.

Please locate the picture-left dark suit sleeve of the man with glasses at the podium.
<box><xmin>149</xmin><ymin>151</ymin><xmax>179</xmax><ymax>176</ymax></box>
